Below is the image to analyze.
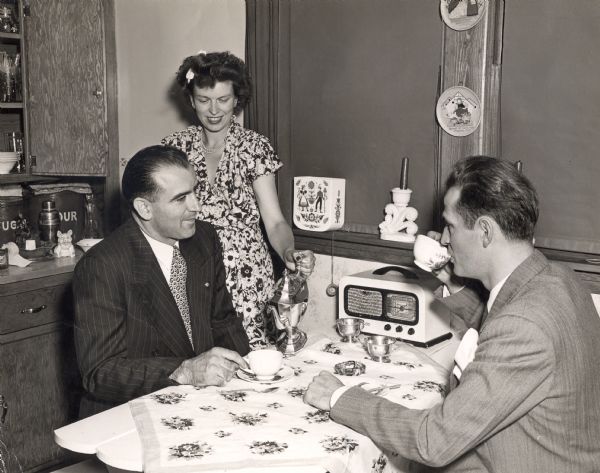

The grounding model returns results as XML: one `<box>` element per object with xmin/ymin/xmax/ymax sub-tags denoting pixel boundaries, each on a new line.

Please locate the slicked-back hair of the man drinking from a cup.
<box><xmin>446</xmin><ymin>156</ymin><xmax>539</xmax><ymax>241</ymax></box>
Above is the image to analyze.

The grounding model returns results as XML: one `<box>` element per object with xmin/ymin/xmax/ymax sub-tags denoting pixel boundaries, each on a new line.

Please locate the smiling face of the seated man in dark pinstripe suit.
<box><xmin>147</xmin><ymin>166</ymin><xmax>199</xmax><ymax>245</ymax></box>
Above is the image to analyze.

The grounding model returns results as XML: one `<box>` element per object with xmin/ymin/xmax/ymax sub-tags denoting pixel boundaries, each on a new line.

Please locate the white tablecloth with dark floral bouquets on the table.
<box><xmin>129</xmin><ymin>339</ymin><xmax>447</xmax><ymax>473</ymax></box>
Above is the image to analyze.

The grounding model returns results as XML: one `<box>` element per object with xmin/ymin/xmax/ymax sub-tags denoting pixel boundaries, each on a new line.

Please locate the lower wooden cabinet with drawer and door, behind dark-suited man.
<box><xmin>0</xmin><ymin>273</ymin><xmax>81</xmax><ymax>472</ymax></box>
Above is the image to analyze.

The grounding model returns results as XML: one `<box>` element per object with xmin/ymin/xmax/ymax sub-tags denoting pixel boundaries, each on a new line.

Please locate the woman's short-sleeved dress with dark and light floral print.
<box><xmin>162</xmin><ymin>122</ymin><xmax>282</xmax><ymax>347</ymax></box>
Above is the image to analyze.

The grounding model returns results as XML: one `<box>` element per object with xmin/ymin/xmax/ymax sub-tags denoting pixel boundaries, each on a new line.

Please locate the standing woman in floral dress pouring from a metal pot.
<box><xmin>162</xmin><ymin>52</ymin><xmax>315</xmax><ymax>348</ymax></box>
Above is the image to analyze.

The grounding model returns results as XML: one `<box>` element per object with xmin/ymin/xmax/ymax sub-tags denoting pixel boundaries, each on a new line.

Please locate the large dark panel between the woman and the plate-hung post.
<box><xmin>290</xmin><ymin>0</ymin><xmax>442</xmax><ymax>231</ymax></box>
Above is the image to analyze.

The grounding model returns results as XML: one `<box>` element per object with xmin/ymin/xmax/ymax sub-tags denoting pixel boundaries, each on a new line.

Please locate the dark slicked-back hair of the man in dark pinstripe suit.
<box><xmin>121</xmin><ymin>145</ymin><xmax>190</xmax><ymax>209</ymax></box>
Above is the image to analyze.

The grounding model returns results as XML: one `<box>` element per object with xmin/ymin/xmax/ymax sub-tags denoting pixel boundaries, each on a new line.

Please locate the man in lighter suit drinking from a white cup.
<box><xmin>305</xmin><ymin>157</ymin><xmax>600</xmax><ymax>473</ymax></box>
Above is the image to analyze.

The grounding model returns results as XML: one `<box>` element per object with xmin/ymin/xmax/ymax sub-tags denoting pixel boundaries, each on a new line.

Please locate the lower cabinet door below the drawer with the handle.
<box><xmin>0</xmin><ymin>324</ymin><xmax>78</xmax><ymax>472</ymax></box>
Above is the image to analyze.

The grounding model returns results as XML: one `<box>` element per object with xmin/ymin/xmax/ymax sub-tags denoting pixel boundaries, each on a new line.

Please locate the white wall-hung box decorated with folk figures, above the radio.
<box><xmin>293</xmin><ymin>176</ymin><xmax>346</xmax><ymax>232</ymax></box>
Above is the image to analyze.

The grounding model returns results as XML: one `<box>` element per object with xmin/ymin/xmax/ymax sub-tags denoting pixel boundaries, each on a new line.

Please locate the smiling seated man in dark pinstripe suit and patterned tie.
<box><xmin>73</xmin><ymin>146</ymin><xmax>249</xmax><ymax>417</ymax></box>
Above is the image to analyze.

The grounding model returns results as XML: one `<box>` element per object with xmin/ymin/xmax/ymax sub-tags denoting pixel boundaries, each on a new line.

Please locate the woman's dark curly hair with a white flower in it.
<box><xmin>176</xmin><ymin>51</ymin><xmax>252</xmax><ymax>115</ymax></box>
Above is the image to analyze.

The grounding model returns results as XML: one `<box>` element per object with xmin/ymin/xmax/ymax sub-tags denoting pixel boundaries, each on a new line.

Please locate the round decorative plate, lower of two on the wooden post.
<box><xmin>435</xmin><ymin>86</ymin><xmax>481</xmax><ymax>136</ymax></box>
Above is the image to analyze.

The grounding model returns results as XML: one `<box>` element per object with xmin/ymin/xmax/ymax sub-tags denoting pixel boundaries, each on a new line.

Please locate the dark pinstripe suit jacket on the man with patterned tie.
<box><xmin>73</xmin><ymin>219</ymin><xmax>249</xmax><ymax>417</ymax></box>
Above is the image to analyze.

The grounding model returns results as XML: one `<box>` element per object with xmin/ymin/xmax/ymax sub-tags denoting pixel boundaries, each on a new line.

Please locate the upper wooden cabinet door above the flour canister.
<box><xmin>25</xmin><ymin>0</ymin><xmax>108</xmax><ymax>176</ymax></box>
